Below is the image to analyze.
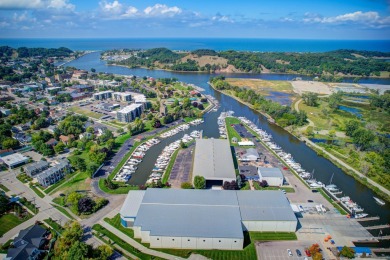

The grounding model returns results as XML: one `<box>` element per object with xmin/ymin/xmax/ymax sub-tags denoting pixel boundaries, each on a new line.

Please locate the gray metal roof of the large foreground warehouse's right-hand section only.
<box><xmin>237</xmin><ymin>190</ymin><xmax>297</xmax><ymax>221</ymax></box>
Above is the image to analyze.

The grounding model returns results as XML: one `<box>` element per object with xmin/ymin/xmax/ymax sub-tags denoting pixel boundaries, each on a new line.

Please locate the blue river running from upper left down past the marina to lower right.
<box><xmin>67</xmin><ymin>52</ymin><xmax>390</xmax><ymax>247</ymax></box>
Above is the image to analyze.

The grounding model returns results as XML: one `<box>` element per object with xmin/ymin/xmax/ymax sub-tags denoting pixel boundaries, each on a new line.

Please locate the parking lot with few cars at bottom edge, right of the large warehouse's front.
<box><xmin>256</xmin><ymin>240</ymin><xmax>322</xmax><ymax>260</ymax></box>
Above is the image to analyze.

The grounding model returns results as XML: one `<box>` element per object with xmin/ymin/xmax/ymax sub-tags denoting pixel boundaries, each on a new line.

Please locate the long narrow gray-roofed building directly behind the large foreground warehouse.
<box><xmin>192</xmin><ymin>139</ymin><xmax>236</xmax><ymax>186</ymax></box>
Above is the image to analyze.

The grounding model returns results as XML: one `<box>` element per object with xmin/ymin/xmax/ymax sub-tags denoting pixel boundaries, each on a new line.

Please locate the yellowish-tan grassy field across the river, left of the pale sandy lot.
<box><xmin>226</xmin><ymin>78</ymin><xmax>294</xmax><ymax>95</ymax></box>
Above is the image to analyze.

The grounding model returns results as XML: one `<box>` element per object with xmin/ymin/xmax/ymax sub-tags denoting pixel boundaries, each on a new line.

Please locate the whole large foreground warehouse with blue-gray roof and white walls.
<box><xmin>120</xmin><ymin>189</ymin><xmax>297</xmax><ymax>250</ymax></box>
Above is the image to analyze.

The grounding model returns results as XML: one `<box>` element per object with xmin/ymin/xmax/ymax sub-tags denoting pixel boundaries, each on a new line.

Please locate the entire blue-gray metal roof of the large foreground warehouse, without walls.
<box><xmin>120</xmin><ymin>189</ymin><xmax>296</xmax><ymax>238</ymax></box>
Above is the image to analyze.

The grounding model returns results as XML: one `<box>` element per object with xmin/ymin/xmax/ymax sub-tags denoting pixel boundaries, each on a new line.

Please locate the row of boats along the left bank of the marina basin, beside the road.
<box><xmin>113</xmin><ymin>138</ymin><xmax>160</xmax><ymax>182</ymax></box>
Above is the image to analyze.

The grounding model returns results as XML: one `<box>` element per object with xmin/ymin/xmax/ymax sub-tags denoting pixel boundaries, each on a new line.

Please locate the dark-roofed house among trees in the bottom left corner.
<box><xmin>5</xmin><ymin>225</ymin><xmax>50</xmax><ymax>260</ymax></box>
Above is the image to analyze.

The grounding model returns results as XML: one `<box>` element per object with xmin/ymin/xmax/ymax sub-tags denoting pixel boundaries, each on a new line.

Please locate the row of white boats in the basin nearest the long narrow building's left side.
<box><xmin>146</xmin><ymin>130</ymin><xmax>201</xmax><ymax>183</ymax></box>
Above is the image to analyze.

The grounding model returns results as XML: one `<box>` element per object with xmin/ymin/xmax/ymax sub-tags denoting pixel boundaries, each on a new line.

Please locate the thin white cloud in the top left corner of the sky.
<box><xmin>0</xmin><ymin>0</ymin><xmax>75</xmax><ymax>10</ymax></box>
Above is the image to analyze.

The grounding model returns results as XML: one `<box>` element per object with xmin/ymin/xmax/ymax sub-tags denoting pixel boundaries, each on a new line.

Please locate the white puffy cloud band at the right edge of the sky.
<box><xmin>303</xmin><ymin>11</ymin><xmax>390</xmax><ymax>28</ymax></box>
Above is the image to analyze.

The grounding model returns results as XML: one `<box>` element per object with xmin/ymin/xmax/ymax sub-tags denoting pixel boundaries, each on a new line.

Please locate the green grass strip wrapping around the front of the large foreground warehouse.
<box><xmin>104</xmin><ymin>214</ymin><xmax>297</xmax><ymax>260</ymax></box>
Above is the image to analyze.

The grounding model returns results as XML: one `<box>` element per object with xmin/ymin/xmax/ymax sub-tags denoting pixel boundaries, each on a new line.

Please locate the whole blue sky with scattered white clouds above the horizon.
<box><xmin>0</xmin><ymin>0</ymin><xmax>390</xmax><ymax>40</ymax></box>
